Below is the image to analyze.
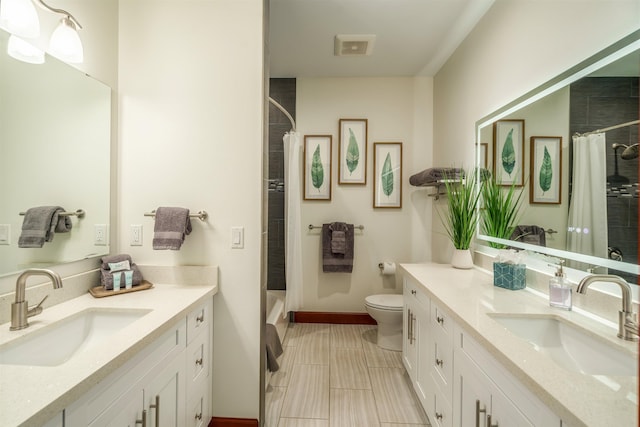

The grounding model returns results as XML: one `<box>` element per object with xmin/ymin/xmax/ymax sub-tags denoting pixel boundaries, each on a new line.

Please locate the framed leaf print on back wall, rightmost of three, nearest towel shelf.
<box><xmin>373</xmin><ymin>142</ymin><xmax>402</xmax><ymax>208</ymax></box>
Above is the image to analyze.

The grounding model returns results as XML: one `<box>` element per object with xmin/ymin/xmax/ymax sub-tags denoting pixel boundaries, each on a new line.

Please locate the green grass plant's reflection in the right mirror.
<box><xmin>480</xmin><ymin>177</ymin><xmax>524</xmax><ymax>249</ymax></box>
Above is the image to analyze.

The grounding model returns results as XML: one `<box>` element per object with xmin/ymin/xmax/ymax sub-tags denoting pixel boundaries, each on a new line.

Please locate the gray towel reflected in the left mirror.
<box><xmin>18</xmin><ymin>206</ymin><xmax>71</xmax><ymax>248</ymax></box>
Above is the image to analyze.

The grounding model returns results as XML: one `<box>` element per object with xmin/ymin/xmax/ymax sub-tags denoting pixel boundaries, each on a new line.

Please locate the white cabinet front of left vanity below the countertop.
<box><xmin>64</xmin><ymin>301</ymin><xmax>213</xmax><ymax>427</ymax></box>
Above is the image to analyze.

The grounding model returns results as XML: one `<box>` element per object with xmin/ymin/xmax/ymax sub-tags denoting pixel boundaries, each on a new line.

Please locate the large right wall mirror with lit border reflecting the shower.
<box><xmin>476</xmin><ymin>31</ymin><xmax>640</xmax><ymax>283</ymax></box>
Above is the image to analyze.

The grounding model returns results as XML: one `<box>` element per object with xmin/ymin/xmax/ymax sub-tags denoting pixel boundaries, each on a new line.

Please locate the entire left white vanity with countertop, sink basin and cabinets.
<box><xmin>0</xmin><ymin>267</ymin><xmax>218</xmax><ymax>427</ymax></box>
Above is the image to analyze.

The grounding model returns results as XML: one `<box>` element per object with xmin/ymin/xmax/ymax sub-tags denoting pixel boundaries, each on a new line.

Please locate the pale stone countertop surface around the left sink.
<box><xmin>0</xmin><ymin>269</ymin><xmax>218</xmax><ymax>426</ymax></box>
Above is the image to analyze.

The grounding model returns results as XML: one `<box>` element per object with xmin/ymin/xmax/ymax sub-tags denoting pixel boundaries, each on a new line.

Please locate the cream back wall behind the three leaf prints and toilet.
<box><xmin>296</xmin><ymin>78</ymin><xmax>432</xmax><ymax>312</ymax></box>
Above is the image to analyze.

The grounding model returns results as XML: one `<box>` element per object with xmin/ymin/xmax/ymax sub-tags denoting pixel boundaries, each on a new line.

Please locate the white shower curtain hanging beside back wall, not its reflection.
<box><xmin>283</xmin><ymin>131</ymin><xmax>302</xmax><ymax>316</ymax></box>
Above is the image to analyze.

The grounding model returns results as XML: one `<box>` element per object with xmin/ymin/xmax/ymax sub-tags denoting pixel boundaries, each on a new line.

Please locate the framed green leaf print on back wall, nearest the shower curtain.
<box><xmin>303</xmin><ymin>135</ymin><xmax>332</xmax><ymax>200</ymax></box>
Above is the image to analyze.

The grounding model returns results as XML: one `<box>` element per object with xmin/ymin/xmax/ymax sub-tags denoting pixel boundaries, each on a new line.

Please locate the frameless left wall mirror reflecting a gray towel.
<box><xmin>0</xmin><ymin>27</ymin><xmax>111</xmax><ymax>276</ymax></box>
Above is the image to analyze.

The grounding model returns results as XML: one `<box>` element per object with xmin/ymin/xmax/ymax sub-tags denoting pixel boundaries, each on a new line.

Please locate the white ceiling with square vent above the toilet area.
<box><xmin>269</xmin><ymin>0</ymin><xmax>494</xmax><ymax>77</ymax></box>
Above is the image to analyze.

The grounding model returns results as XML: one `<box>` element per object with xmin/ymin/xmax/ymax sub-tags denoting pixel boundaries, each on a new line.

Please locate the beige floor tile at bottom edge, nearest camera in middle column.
<box><xmin>329</xmin><ymin>388</ymin><xmax>380</xmax><ymax>427</ymax></box>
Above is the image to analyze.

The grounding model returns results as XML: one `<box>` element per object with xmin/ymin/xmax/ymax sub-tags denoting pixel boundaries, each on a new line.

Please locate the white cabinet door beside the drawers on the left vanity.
<box><xmin>144</xmin><ymin>352</ymin><xmax>186</xmax><ymax>427</ymax></box>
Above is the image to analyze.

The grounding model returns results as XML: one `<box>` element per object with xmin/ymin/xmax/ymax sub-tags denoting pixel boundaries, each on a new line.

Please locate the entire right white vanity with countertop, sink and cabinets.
<box><xmin>401</xmin><ymin>264</ymin><xmax>638</xmax><ymax>427</ymax></box>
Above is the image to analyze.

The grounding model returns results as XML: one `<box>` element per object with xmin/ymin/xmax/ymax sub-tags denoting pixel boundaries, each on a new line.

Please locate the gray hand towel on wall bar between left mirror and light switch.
<box><xmin>153</xmin><ymin>207</ymin><xmax>191</xmax><ymax>250</ymax></box>
